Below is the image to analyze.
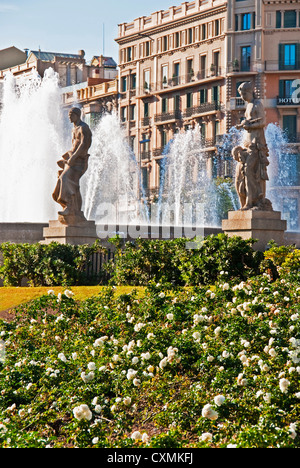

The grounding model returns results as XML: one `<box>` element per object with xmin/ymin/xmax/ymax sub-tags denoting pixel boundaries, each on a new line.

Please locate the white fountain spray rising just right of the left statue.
<box><xmin>82</xmin><ymin>113</ymin><xmax>149</xmax><ymax>224</ymax></box>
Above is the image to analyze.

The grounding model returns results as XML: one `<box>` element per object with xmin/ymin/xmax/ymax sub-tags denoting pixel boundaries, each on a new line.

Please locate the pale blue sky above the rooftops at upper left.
<box><xmin>0</xmin><ymin>0</ymin><xmax>175</xmax><ymax>61</ymax></box>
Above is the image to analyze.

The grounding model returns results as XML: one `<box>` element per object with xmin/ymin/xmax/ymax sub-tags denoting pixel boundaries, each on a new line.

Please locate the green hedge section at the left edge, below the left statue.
<box><xmin>0</xmin><ymin>241</ymin><xmax>105</xmax><ymax>286</ymax></box>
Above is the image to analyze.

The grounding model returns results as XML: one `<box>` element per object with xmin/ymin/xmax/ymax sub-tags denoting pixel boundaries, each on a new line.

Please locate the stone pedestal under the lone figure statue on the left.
<box><xmin>42</xmin><ymin>221</ymin><xmax>98</xmax><ymax>245</ymax></box>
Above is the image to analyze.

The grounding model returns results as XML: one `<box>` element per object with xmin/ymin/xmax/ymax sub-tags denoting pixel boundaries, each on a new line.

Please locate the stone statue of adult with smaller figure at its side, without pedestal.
<box><xmin>232</xmin><ymin>82</ymin><xmax>273</xmax><ymax>211</ymax></box>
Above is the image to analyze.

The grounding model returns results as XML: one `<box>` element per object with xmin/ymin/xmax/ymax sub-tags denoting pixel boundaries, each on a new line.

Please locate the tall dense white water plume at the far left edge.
<box><xmin>0</xmin><ymin>69</ymin><xmax>64</xmax><ymax>222</ymax></box>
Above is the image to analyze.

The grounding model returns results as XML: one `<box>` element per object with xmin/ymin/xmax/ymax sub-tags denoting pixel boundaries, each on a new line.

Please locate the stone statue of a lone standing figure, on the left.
<box><xmin>52</xmin><ymin>107</ymin><xmax>92</xmax><ymax>225</ymax></box>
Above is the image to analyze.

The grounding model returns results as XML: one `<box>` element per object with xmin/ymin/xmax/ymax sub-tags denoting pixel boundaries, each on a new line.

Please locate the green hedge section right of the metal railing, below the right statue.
<box><xmin>111</xmin><ymin>234</ymin><xmax>263</xmax><ymax>286</ymax></box>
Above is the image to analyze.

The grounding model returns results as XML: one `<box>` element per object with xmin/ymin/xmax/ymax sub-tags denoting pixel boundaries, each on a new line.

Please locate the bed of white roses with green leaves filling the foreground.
<box><xmin>0</xmin><ymin>271</ymin><xmax>300</xmax><ymax>448</ymax></box>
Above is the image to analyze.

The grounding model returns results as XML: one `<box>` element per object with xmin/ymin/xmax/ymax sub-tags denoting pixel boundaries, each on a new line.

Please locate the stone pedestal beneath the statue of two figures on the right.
<box><xmin>222</xmin><ymin>210</ymin><xmax>287</xmax><ymax>251</ymax></box>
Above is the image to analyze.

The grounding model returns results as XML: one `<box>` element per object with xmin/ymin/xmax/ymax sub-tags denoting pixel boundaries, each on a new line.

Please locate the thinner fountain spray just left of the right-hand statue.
<box><xmin>158</xmin><ymin>126</ymin><xmax>241</xmax><ymax>226</ymax></box>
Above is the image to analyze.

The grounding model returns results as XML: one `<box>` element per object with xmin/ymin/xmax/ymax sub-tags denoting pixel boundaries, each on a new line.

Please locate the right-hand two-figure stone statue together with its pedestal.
<box><xmin>222</xmin><ymin>82</ymin><xmax>287</xmax><ymax>250</ymax></box>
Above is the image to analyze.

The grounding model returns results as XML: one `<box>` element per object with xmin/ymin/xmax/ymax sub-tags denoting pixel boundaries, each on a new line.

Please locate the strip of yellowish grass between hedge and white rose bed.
<box><xmin>0</xmin><ymin>286</ymin><xmax>144</xmax><ymax>312</ymax></box>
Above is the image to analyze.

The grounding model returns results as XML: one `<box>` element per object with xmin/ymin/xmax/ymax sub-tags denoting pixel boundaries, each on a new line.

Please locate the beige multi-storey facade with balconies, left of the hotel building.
<box><xmin>117</xmin><ymin>0</ymin><xmax>226</xmax><ymax>199</ymax></box>
